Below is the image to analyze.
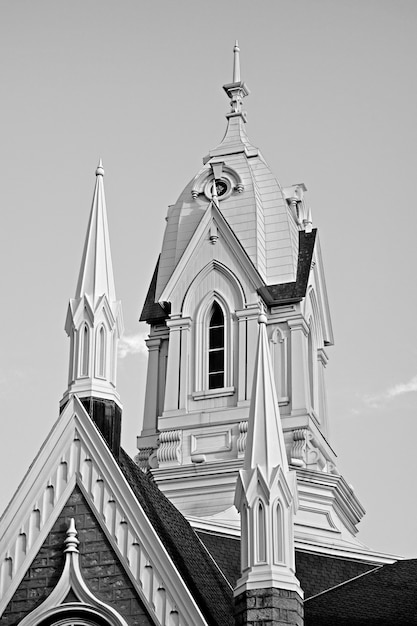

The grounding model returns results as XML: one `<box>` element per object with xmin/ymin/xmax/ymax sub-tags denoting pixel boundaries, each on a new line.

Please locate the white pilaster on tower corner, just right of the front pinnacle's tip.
<box><xmin>288</xmin><ymin>316</ymin><xmax>309</xmax><ymax>415</ymax></box>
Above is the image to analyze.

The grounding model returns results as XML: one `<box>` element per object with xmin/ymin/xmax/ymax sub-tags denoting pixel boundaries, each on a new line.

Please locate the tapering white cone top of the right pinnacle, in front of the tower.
<box><xmin>243</xmin><ymin>314</ymin><xmax>288</xmax><ymax>478</ymax></box>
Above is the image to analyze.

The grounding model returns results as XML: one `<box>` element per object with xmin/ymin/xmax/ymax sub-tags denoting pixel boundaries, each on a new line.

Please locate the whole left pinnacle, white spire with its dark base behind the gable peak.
<box><xmin>61</xmin><ymin>159</ymin><xmax>123</xmax><ymax>452</ymax></box>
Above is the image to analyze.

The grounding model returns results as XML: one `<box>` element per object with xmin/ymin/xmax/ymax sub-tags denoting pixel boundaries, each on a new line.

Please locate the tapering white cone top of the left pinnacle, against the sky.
<box><xmin>75</xmin><ymin>159</ymin><xmax>116</xmax><ymax>307</ymax></box>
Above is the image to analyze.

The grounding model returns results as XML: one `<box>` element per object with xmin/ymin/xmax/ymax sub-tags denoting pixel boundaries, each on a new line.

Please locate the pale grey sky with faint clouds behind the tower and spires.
<box><xmin>0</xmin><ymin>0</ymin><xmax>417</xmax><ymax>557</ymax></box>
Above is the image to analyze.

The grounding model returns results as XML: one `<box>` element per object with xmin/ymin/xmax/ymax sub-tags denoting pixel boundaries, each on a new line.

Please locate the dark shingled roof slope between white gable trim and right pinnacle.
<box><xmin>119</xmin><ymin>450</ymin><xmax>234</xmax><ymax>626</ymax></box>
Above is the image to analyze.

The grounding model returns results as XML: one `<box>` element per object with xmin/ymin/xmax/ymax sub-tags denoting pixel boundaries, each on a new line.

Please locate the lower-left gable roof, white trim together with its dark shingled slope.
<box><xmin>0</xmin><ymin>396</ymin><xmax>233</xmax><ymax>626</ymax></box>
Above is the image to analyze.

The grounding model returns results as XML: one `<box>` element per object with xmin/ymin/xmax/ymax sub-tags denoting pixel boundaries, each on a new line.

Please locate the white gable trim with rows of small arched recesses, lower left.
<box><xmin>0</xmin><ymin>396</ymin><xmax>206</xmax><ymax>626</ymax></box>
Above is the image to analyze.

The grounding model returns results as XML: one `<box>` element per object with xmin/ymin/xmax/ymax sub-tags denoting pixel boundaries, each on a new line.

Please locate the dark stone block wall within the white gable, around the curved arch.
<box><xmin>0</xmin><ymin>487</ymin><xmax>153</xmax><ymax>626</ymax></box>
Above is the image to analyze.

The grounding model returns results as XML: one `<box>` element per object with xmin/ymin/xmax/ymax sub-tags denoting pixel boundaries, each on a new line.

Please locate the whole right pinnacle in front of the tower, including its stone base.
<box><xmin>235</xmin><ymin>314</ymin><xmax>303</xmax><ymax>625</ymax></box>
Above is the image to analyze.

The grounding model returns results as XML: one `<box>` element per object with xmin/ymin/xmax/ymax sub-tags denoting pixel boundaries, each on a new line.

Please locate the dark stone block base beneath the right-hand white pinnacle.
<box><xmin>235</xmin><ymin>588</ymin><xmax>304</xmax><ymax>626</ymax></box>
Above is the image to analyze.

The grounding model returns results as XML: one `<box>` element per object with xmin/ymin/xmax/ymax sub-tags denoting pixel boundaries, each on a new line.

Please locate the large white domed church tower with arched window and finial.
<box><xmin>138</xmin><ymin>42</ymin><xmax>364</xmax><ymax>554</ymax></box>
